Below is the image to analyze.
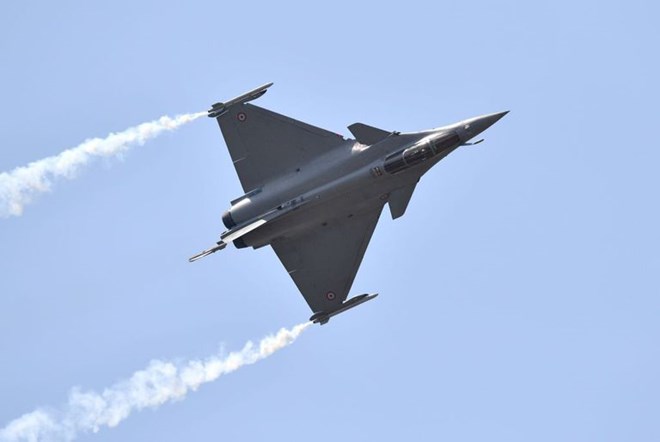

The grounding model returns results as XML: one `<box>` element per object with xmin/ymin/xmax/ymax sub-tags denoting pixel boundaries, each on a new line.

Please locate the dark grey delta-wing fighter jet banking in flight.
<box><xmin>190</xmin><ymin>83</ymin><xmax>507</xmax><ymax>324</ymax></box>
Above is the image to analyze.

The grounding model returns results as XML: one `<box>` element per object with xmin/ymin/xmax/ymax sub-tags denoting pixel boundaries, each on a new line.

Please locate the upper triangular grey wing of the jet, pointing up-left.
<box><xmin>217</xmin><ymin>104</ymin><xmax>346</xmax><ymax>192</ymax></box>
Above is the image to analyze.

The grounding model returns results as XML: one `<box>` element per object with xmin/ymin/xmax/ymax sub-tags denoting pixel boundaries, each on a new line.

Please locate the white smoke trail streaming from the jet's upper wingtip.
<box><xmin>0</xmin><ymin>112</ymin><xmax>206</xmax><ymax>218</ymax></box>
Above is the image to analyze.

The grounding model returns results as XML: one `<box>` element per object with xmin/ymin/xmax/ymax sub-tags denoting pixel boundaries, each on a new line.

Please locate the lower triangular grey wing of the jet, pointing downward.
<box><xmin>271</xmin><ymin>200</ymin><xmax>384</xmax><ymax>323</ymax></box>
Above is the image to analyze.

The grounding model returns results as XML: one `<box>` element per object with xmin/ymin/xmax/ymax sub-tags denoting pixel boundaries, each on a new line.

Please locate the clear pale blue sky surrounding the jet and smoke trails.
<box><xmin>0</xmin><ymin>0</ymin><xmax>660</xmax><ymax>442</ymax></box>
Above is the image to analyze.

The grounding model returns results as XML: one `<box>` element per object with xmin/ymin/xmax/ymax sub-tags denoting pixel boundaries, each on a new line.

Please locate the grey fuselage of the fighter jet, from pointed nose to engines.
<box><xmin>223</xmin><ymin>113</ymin><xmax>504</xmax><ymax>248</ymax></box>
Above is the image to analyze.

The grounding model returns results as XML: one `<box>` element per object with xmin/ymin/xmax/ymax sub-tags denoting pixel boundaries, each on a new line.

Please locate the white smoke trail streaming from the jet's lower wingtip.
<box><xmin>0</xmin><ymin>322</ymin><xmax>312</xmax><ymax>442</ymax></box>
